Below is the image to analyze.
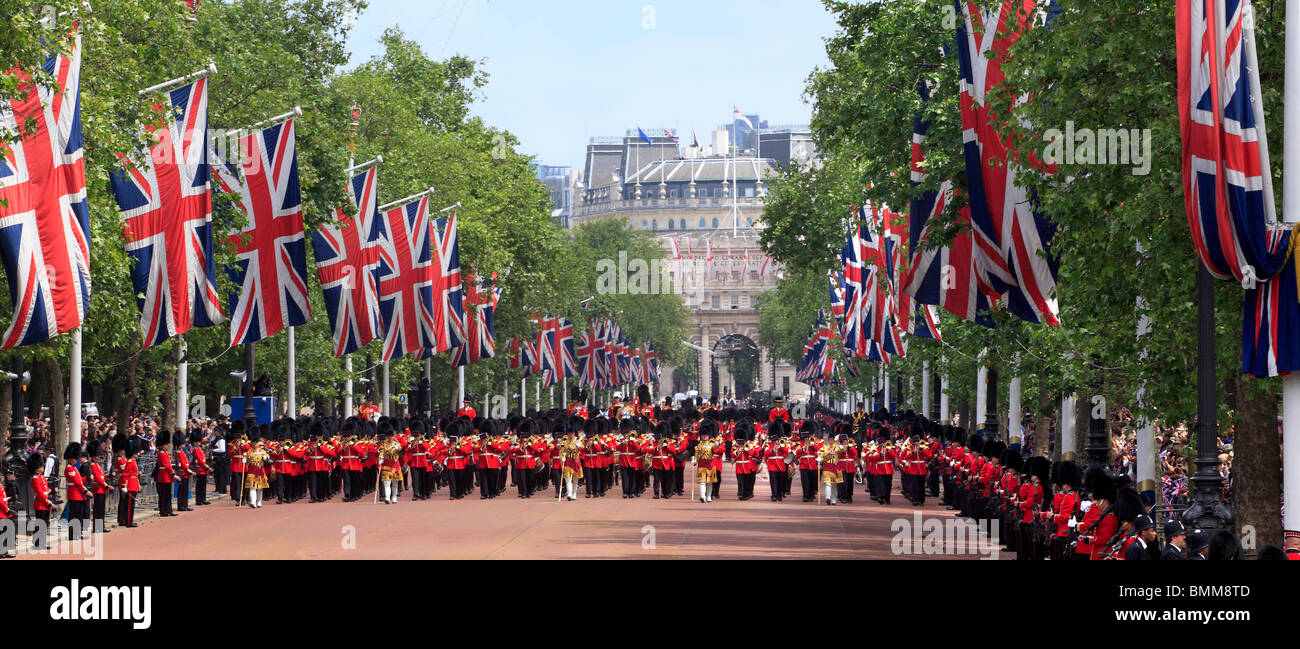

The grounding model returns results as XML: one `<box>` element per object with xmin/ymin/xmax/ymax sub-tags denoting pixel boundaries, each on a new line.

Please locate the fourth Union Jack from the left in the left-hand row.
<box><xmin>312</xmin><ymin>166</ymin><xmax>382</xmax><ymax>356</ymax></box>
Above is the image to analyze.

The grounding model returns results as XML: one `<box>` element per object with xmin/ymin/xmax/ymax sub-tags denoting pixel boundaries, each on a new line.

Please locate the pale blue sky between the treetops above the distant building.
<box><xmin>350</xmin><ymin>0</ymin><xmax>835</xmax><ymax>166</ymax></box>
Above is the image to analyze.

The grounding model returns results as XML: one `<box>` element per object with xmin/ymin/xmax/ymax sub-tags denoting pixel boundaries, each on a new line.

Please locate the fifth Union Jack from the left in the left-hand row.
<box><xmin>376</xmin><ymin>196</ymin><xmax>436</xmax><ymax>360</ymax></box>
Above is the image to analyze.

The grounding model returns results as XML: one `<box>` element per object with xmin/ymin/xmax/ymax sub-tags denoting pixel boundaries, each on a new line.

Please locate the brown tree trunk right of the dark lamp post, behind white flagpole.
<box><xmin>1232</xmin><ymin>375</ymin><xmax>1283</xmax><ymax>549</ymax></box>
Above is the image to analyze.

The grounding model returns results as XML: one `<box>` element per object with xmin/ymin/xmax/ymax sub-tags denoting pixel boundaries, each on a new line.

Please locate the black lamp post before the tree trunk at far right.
<box><xmin>1182</xmin><ymin>264</ymin><xmax>1234</xmax><ymax>531</ymax></box>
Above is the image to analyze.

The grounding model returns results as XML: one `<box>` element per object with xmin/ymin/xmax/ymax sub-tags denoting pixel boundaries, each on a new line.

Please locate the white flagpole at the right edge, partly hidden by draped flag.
<box><xmin>1274</xmin><ymin>0</ymin><xmax>1300</xmax><ymax>549</ymax></box>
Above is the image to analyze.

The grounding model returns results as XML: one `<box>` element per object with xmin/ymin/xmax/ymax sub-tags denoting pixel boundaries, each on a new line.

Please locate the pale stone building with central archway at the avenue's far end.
<box><xmin>569</xmin><ymin>116</ymin><xmax>815</xmax><ymax>398</ymax></box>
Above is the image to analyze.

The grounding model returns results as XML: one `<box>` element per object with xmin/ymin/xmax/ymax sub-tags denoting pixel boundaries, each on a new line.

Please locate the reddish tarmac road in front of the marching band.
<box><xmin>25</xmin><ymin>466</ymin><xmax>1011</xmax><ymax>559</ymax></box>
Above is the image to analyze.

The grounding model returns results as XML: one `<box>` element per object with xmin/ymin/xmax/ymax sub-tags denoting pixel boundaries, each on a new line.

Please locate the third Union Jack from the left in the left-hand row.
<box><xmin>217</xmin><ymin>120</ymin><xmax>312</xmax><ymax>345</ymax></box>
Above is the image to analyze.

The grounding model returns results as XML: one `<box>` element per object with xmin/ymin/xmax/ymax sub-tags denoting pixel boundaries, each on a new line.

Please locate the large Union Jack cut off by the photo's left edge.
<box><xmin>0</xmin><ymin>34</ymin><xmax>91</xmax><ymax>349</ymax></box>
